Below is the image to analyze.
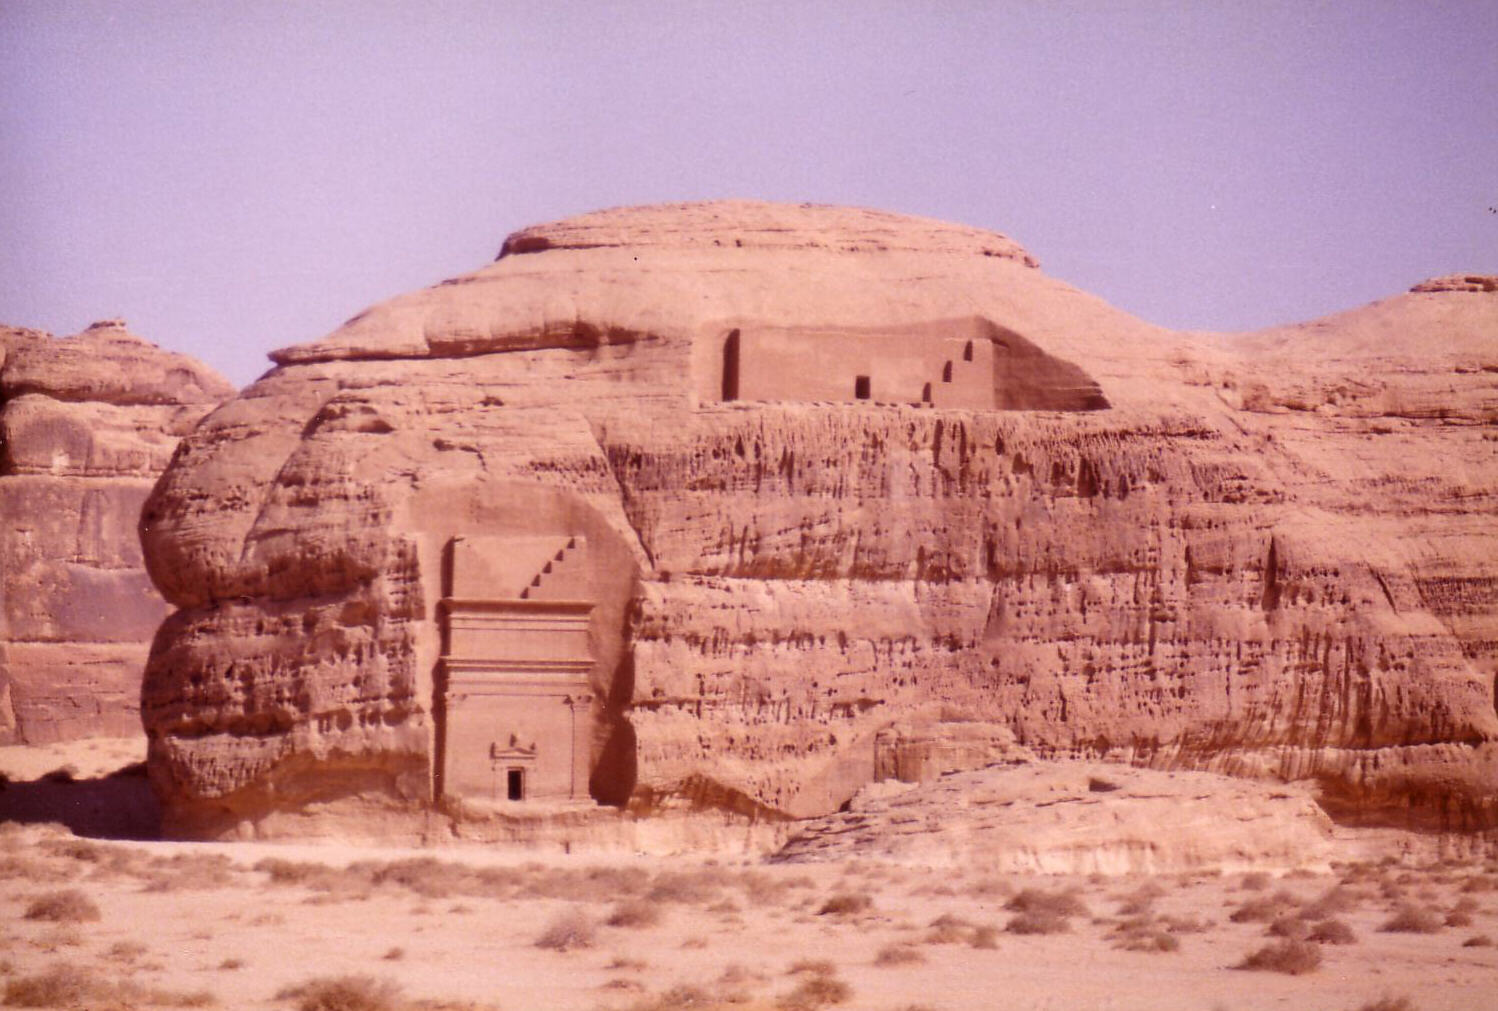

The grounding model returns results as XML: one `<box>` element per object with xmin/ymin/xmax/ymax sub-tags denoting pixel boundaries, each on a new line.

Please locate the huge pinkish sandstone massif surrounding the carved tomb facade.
<box><xmin>141</xmin><ymin>202</ymin><xmax>1498</xmax><ymax>836</ymax></box>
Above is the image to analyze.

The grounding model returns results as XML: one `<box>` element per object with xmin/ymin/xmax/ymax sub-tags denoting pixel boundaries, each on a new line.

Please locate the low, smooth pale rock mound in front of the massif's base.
<box><xmin>774</xmin><ymin>761</ymin><xmax>1342</xmax><ymax>875</ymax></box>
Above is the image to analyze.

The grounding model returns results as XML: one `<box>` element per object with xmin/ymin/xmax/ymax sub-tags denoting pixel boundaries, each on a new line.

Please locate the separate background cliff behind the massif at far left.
<box><xmin>0</xmin><ymin>322</ymin><xmax>234</xmax><ymax>744</ymax></box>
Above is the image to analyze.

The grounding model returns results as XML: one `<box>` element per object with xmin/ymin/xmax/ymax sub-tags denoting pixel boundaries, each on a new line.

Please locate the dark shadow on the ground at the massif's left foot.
<box><xmin>0</xmin><ymin>762</ymin><xmax>162</xmax><ymax>839</ymax></box>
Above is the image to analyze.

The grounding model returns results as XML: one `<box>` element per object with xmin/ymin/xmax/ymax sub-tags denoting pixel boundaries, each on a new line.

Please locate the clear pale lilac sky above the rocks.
<box><xmin>0</xmin><ymin>0</ymin><xmax>1498</xmax><ymax>385</ymax></box>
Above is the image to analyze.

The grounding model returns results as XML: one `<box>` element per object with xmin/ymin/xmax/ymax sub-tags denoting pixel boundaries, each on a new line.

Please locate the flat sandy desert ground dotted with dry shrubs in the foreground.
<box><xmin>0</xmin><ymin>747</ymin><xmax>1498</xmax><ymax>1011</ymax></box>
